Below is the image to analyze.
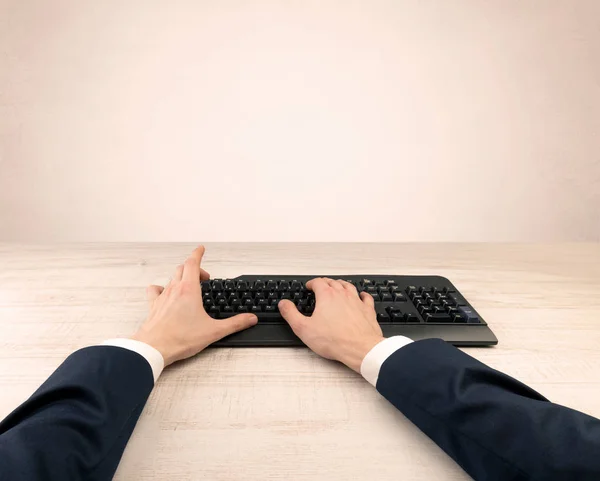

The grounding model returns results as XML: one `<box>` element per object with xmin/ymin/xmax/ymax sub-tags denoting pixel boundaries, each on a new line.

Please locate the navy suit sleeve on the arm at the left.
<box><xmin>0</xmin><ymin>346</ymin><xmax>154</xmax><ymax>481</ymax></box>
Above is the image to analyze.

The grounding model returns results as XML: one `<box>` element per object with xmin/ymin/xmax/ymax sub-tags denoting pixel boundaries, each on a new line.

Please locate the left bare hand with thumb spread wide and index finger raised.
<box><xmin>132</xmin><ymin>246</ymin><xmax>258</xmax><ymax>366</ymax></box>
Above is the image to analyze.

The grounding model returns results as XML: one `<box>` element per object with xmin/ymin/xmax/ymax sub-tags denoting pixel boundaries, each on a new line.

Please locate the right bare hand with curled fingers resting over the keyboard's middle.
<box><xmin>279</xmin><ymin>278</ymin><xmax>383</xmax><ymax>372</ymax></box>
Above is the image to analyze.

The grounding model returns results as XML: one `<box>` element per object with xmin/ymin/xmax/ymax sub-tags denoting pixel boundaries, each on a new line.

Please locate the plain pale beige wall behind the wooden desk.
<box><xmin>0</xmin><ymin>0</ymin><xmax>600</xmax><ymax>241</ymax></box>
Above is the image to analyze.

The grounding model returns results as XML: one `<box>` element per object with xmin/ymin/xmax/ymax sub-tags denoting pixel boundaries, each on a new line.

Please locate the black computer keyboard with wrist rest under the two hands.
<box><xmin>202</xmin><ymin>275</ymin><xmax>498</xmax><ymax>347</ymax></box>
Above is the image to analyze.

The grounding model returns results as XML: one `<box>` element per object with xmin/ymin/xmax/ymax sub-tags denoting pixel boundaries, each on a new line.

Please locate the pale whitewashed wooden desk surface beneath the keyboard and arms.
<box><xmin>0</xmin><ymin>244</ymin><xmax>600</xmax><ymax>481</ymax></box>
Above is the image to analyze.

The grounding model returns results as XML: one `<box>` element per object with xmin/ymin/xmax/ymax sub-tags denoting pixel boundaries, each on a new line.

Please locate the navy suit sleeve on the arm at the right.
<box><xmin>377</xmin><ymin>339</ymin><xmax>600</xmax><ymax>481</ymax></box>
